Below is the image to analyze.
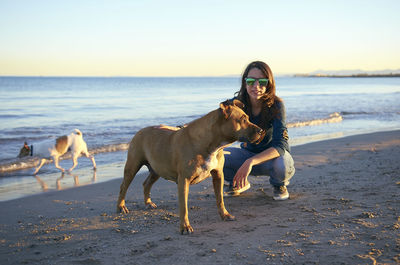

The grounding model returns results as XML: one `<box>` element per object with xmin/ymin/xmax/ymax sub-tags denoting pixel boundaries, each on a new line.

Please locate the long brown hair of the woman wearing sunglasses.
<box><xmin>235</xmin><ymin>61</ymin><xmax>282</xmax><ymax>129</ymax></box>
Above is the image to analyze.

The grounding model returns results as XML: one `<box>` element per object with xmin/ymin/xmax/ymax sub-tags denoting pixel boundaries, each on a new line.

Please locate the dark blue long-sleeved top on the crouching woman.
<box><xmin>240</xmin><ymin>98</ymin><xmax>290</xmax><ymax>156</ymax></box>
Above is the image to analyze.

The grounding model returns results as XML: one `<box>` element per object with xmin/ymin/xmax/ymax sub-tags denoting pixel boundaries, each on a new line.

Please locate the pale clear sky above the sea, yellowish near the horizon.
<box><xmin>0</xmin><ymin>0</ymin><xmax>400</xmax><ymax>76</ymax></box>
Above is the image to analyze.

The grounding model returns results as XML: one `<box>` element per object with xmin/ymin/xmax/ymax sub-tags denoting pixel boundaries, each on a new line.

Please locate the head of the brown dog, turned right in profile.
<box><xmin>220</xmin><ymin>99</ymin><xmax>265</xmax><ymax>143</ymax></box>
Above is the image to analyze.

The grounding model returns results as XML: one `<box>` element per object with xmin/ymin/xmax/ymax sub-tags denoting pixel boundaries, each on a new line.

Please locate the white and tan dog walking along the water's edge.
<box><xmin>18</xmin><ymin>129</ymin><xmax>96</xmax><ymax>174</ymax></box>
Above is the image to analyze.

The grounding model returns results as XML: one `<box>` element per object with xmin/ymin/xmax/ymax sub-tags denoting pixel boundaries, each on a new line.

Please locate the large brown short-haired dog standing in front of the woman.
<box><xmin>117</xmin><ymin>100</ymin><xmax>263</xmax><ymax>234</ymax></box>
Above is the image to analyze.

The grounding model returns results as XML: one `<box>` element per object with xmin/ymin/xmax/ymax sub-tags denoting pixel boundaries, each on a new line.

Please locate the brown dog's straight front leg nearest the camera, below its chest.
<box><xmin>178</xmin><ymin>175</ymin><xmax>193</xmax><ymax>235</ymax></box>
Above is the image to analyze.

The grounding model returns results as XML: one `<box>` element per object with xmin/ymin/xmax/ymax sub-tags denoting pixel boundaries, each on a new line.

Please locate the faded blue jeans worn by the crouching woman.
<box><xmin>224</xmin><ymin>147</ymin><xmax>295</xmax><ymax>186</ymax></box>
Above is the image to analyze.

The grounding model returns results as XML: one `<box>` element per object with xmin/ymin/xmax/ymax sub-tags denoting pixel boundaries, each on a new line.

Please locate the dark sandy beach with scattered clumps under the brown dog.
<box><xmin>0</xmin><ymin>131</ymin><xmax>400</xmax><ymax>264</ymax></box>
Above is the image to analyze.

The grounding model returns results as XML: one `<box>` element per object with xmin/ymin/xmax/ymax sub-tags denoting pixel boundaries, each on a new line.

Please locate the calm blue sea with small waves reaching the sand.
<box><xmin>0</xmin><ymin>76</ymin><xmax>400</xmax><ymax>201</ymax></box>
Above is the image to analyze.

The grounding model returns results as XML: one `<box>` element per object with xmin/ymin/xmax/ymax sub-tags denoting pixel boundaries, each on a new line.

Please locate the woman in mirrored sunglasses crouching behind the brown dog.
<box><xmin>224</xmin><ymin>61</ymin><xmax>295</xmax><ymax>200</ymax></box>
